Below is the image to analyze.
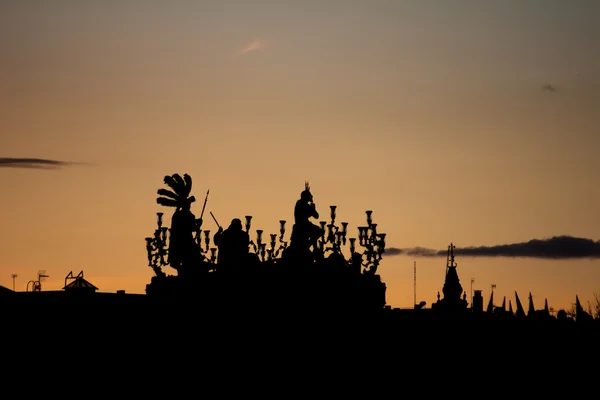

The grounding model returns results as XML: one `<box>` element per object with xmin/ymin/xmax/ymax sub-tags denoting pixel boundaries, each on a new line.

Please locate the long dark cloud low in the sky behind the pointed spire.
<box><xmin>385</xmin><ymin>236</ymin><xmax>600</xmax><ymax>259</ymax></box>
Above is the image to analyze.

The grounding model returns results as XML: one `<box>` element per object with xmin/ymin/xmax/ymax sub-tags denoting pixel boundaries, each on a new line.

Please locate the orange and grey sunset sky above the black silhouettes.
<box><xmin>0</xmin><ymin>0</ymin><xmax>600</xmax><ymax>309</ymax></box>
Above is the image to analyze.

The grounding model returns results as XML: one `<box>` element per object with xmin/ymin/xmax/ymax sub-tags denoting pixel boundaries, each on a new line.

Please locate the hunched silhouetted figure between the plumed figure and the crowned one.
<box><xmin>214</xmin><ymin>218</ymin><xmax>250</xmax><ymax>270</ymax></box>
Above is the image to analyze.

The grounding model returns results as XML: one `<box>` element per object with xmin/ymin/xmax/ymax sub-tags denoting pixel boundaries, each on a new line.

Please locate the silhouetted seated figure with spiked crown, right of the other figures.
<box><xmin>290</xmin><ymin>182</ymin><xmax>323</xmax><ymax>250</ymax></box>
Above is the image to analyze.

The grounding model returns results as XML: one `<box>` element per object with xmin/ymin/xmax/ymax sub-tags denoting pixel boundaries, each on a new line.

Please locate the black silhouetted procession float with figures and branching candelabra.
<box><xmin>146</xmin><ymin>174</ymin><xmax>386</xmax><ymax>314</ymax></box>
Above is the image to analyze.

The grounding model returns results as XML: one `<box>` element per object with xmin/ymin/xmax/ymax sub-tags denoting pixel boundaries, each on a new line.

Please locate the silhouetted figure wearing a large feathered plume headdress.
<box><xmin>156</xmin><ymin>174</ymin><xmax>202</xmax><ymax>274</ymax></box>
